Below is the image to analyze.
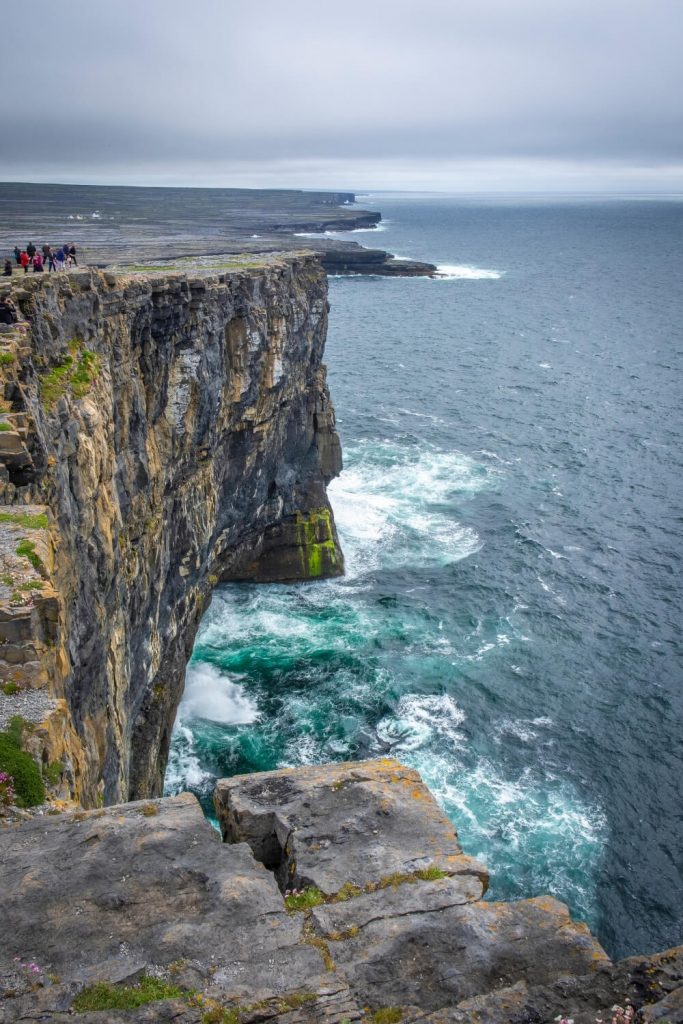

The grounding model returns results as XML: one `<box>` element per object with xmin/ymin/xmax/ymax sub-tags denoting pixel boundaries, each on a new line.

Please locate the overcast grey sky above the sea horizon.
<box><xmin>0</xmin><ymin>0</ymin><xmax>683</xmax><ymax>191</ymax></box>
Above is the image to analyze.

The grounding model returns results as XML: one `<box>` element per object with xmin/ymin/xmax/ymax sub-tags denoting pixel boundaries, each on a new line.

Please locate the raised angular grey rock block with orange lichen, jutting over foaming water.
<box><xmin>214</xmin><ymin>758</ymin><xmax>487</xmax><ymax>895</ymax></box>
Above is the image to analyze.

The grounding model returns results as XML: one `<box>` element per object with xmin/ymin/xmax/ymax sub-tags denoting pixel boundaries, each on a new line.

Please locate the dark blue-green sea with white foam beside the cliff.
<box><xmin>168</xmin><ymin>197</ymin><xmax>683</xmax><ymax>955</ymax></box>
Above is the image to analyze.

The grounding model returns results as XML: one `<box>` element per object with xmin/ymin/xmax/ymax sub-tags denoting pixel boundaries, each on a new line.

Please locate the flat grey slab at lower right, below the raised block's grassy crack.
<box><xmin>313</xmin><ymin>881</ymin><xmax>610</xmax><ymax>1011</ymax></box>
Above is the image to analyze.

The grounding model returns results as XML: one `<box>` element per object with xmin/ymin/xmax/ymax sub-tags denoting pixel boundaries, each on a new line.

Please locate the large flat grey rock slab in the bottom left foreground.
<box><xmin>0</xmin><ymin>794</ymin><xmax>325</xmax><ymax>1019</ymax></box>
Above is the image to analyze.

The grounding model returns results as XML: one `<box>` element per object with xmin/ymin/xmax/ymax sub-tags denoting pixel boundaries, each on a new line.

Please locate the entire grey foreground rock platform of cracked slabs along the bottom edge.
<box><xmin>0</xmin><ymin>759</ymin><xmax>683</xmax><ymax>1024</ymax></box>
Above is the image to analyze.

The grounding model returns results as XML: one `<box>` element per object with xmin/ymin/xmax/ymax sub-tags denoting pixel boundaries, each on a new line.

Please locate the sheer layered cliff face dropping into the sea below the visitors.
<box><xmin>5</xmin><ymin>256</ymin><xmax>343</xmax><ymax>805</ymax></box>
